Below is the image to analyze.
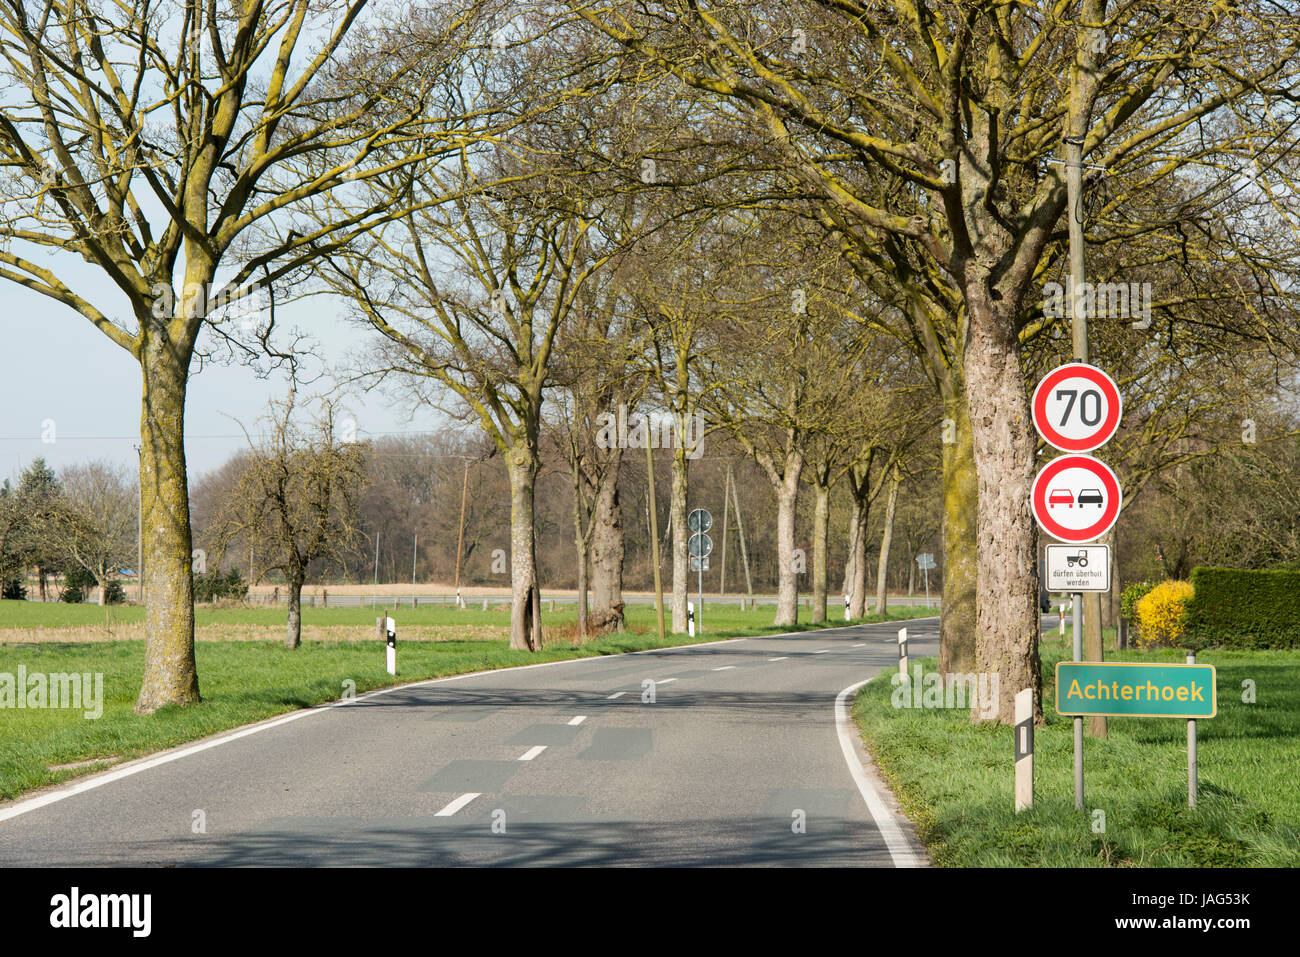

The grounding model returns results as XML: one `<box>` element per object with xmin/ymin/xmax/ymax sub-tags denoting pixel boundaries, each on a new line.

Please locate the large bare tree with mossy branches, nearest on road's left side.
<box><xmin>0</xmin><ymin>0</ymin><xmax>501</xmax><ymax>713</ymax></box>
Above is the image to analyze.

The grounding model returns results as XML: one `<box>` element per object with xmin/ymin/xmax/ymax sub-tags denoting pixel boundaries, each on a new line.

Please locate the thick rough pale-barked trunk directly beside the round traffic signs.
<box><xmin>963</xmin><ymin>299</ymin><xmax>1043</xmax><ymax>724</ymax></box>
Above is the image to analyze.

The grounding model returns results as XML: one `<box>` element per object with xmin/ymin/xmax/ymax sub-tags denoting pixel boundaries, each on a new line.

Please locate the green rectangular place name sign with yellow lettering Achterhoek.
<box><xmin>1057</xmin><ymin>662</ymin><xmax>1218</xmax><ymax>718</ymax></box>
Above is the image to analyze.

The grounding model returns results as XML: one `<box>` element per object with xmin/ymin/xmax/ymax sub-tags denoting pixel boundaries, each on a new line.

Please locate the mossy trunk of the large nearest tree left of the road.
<box><xmin>135</xmin><ymin>328</ymin><xmax>199</xmax><ymax>714</ymax></box>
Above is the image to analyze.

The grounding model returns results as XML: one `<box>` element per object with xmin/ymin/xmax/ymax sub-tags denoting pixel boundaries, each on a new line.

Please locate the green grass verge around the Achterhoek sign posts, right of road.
<box><xmin>854</xmin><ymin>640</ymin><xmax>1300</xmax><ymax>867</ymax></box>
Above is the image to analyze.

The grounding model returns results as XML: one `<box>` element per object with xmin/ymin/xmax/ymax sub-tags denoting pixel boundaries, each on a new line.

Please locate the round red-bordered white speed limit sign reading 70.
<box><xmin>1032</xmin><ymin>363</ymin><xmax>1123</xmax><ymax>452</ymax></box>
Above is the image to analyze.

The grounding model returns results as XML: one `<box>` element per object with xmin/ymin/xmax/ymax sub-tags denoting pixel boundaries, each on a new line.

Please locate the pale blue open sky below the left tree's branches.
<box><xmin>0</xmin><ymin>273</ymin><xmax>442</xmax><ymax>484</ymax></box>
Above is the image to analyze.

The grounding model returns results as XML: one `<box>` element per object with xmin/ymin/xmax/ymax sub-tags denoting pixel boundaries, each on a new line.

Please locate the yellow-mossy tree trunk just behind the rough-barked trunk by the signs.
<box><xmin>939</xmin><ymin>394</ymin><xmax>979</xmax><ymax>674</ymax></box>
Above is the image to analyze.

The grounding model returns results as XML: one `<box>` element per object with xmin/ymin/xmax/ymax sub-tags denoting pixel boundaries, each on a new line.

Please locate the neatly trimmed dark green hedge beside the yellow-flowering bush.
<box><xmin>1187</xmin><ymin>568</ymin><xmax>1300</xmax><ymax>649</ymax></box>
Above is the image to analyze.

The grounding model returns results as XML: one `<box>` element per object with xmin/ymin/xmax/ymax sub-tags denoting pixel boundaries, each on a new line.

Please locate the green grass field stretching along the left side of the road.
<box><xmin>0</xmin><ymin>602</ymin><xmax>923</xmax><ymax>800</ymax></box>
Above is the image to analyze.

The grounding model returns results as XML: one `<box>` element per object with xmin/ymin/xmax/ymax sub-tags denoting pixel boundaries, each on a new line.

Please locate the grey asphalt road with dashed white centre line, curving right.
<box><xmin>0</xmin><ymin>619</ymin><xmax>993</xmax><ymax>866</ymax></box>
